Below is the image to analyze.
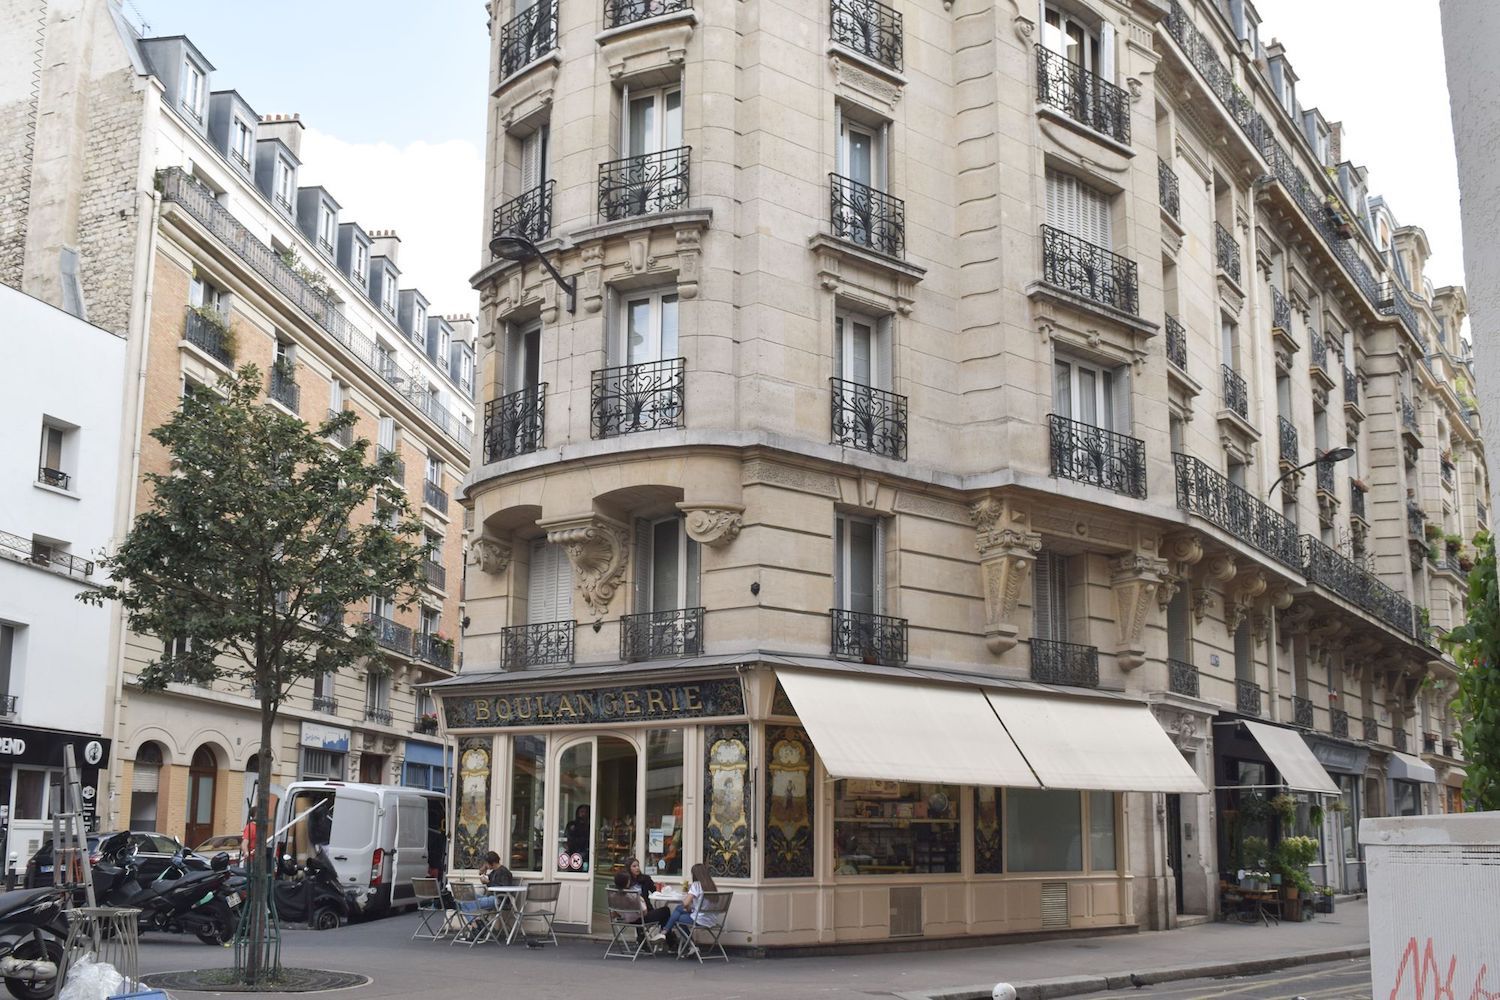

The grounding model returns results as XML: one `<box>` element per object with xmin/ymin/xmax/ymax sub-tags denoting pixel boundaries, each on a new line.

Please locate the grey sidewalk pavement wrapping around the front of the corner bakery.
<box><xmin>141</xmin><ymin>901</ymin><xmax>1370</xmax><ymax>1000</ymax></box>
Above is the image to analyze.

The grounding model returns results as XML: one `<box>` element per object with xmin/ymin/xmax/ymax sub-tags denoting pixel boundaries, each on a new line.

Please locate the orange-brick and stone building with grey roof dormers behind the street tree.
<box><xmin>0</xmin><ymin>0</ymin><xmax>476</xmax><ymax>863</ymax></box>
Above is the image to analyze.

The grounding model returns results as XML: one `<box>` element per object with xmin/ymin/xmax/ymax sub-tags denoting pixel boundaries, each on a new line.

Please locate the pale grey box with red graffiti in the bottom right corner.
<box><xmin>1359</xmin><ymin>813</ymin><xmax>1500</xmax><ymax>1000</ymax></box>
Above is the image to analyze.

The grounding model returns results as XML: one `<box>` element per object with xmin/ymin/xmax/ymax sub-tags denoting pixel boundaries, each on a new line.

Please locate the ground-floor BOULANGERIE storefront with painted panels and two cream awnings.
<box><xmin>431</xmin><ymin>658</ymin><xmax>1205</xmax><ymax>948</ymax></box>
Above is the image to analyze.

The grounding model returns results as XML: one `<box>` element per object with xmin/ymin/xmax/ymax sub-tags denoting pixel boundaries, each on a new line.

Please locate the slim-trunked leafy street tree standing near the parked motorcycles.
<box><xmin>80</xmin><ymin>366</ymin><xmax>425</xmax><ymax>982</ymax></box>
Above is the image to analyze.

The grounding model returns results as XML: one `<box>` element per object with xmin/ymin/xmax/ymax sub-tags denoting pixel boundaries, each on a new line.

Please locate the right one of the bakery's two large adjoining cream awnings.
<box><xmin>984</xmin><ymin>690</ymin><xmax>1208</xmax><ymax>795</ymax></box>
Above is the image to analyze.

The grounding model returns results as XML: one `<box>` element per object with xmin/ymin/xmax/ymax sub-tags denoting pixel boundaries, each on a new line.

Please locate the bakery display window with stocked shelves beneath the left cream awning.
<box><xmin>834</xmin><ymin>778</ymin><xmax>960</xmax><ymax>876</ymax></box>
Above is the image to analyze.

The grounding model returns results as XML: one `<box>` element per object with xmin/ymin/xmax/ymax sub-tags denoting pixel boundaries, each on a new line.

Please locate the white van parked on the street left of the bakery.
<box><xmin>276</xmin><ymin>781</ymin><xmax>449</xmax><ymax>915</ymax></box>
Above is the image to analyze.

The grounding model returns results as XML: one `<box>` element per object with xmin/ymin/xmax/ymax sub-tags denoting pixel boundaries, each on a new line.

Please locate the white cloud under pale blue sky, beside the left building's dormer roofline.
<box><xmin>297</xmin><ymin>129</ymin><xmax>485</xmax><ymax>313</ymax></box>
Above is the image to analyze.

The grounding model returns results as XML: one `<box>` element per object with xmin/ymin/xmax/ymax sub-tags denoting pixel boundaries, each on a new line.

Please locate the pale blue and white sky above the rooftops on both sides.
<box><xmin>122</xmin><ymin>0</ymin><xmax>1464</xmax><ymax>313</ymax></box>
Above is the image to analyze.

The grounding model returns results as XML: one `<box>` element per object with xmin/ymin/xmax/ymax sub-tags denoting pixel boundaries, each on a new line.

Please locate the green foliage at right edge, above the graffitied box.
<box><xmin>1445</xmin><ymin>532</ymin><xmax>1500</xmax><ymax>810</ymax></box>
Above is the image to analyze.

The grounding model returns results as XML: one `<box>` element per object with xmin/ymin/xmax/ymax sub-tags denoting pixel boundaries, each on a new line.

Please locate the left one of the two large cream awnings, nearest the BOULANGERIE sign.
<box><xmin>776</xmin><ymin>670</ymin><xmax>1038</xmax><ymax>789</ymax></box>
